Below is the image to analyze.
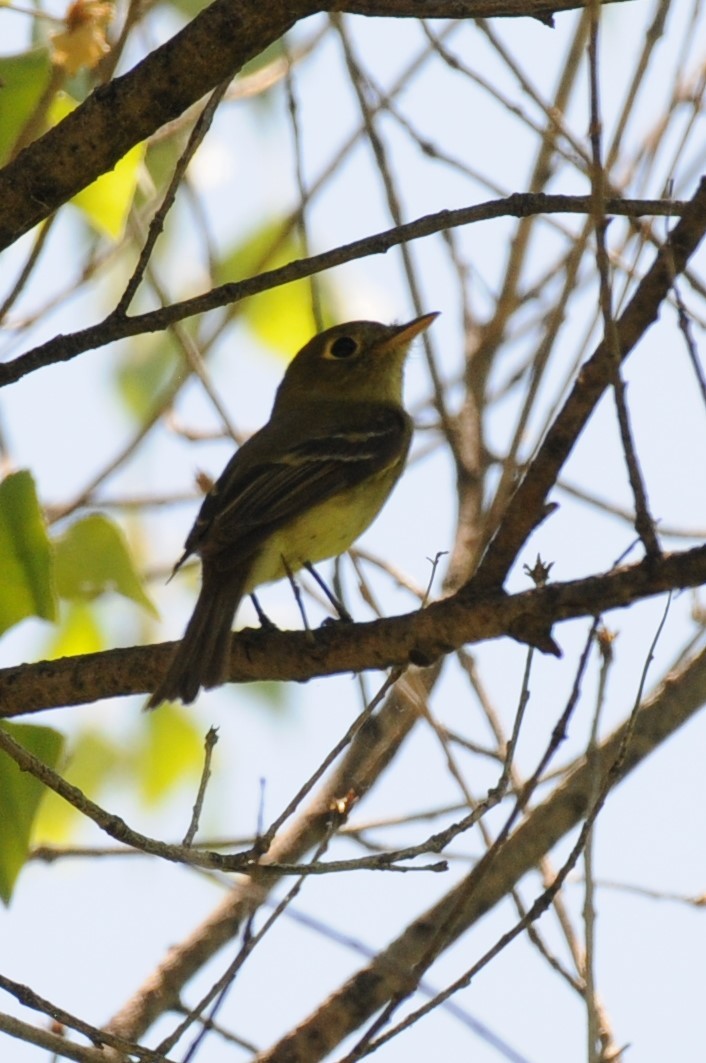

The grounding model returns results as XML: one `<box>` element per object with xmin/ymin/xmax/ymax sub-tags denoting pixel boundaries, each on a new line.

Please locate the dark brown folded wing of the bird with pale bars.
<box><xmin>186</xmin><ymin>405</ymin><xmax>410</xmax><ymax>561</ymax></box>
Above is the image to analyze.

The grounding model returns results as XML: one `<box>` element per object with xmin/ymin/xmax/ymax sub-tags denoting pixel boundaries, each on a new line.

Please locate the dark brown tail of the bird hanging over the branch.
<box><xmin>146</xmin><ymin>567</ymin><xmax>245</xmax><ymax>709</ymax></box>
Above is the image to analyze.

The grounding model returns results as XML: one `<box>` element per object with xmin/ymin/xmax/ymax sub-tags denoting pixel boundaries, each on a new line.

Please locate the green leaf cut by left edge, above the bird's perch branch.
<box><xmin>0</xmin><ymin>471</ymin><xmax>56</xmax><ymax>634</ymax></box>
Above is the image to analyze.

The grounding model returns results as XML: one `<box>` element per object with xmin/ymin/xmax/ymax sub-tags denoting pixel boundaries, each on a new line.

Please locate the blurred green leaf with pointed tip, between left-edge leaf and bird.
<box><xmin>54</xmin><ymin>513</ymin><xmax>158</xmax><ymax>617</ymax></box>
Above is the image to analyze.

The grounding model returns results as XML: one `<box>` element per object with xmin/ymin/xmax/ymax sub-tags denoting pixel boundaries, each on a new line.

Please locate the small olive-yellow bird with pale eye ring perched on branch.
<box><xmin>146</xmin><ymin>313</ymin><xmax>438</xmax><ymax>709</ymax></box>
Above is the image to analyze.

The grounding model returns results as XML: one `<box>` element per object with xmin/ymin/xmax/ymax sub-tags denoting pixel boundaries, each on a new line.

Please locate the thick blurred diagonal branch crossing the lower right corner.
<box><xmin>257</xmin><ymin>637</ymin><xmax>706</xmax><ymax>1063</ymax></box>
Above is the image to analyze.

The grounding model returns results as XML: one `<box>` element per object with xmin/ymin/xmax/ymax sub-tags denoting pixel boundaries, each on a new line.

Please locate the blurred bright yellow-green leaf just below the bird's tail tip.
<box><xmin>135</xmin><ymin>705</ymin><xmax>204</xmax><ymax>805</ymax></box>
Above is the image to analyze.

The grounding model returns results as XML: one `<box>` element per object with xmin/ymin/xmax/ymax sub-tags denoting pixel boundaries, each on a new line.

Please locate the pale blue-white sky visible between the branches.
<box><xmin>0</xmin><ymin>0</ymin><xmax>706</xmax><ymax>1063</ymax></box>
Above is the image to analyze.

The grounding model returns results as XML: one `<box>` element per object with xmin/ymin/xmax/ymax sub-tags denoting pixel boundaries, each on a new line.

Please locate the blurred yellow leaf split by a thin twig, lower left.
<box><xmin>32</xmin><ymin>730</ymin><xmax>123</xmax><ymax>845</ymax></box>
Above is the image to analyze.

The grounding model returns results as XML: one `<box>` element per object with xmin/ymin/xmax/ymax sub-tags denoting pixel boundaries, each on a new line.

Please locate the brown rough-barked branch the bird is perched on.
<box><xmin>0</xmin><ymin>546</ymin><xmax>706</xmax><ymax>718</ymax></box>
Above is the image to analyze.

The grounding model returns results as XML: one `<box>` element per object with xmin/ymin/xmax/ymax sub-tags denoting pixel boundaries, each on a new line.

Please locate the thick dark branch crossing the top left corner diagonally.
<box><xmin>0</xmin><ymin>0</ymin><xmax>629</xmax><ymax>251</ymax></box>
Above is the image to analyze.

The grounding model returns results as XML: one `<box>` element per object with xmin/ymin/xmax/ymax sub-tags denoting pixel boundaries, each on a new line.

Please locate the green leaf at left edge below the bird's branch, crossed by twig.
<box><xmin>0</xmin><ymin>723</ymin><xmax>64</xmax><ymax>905</ymax></box>
